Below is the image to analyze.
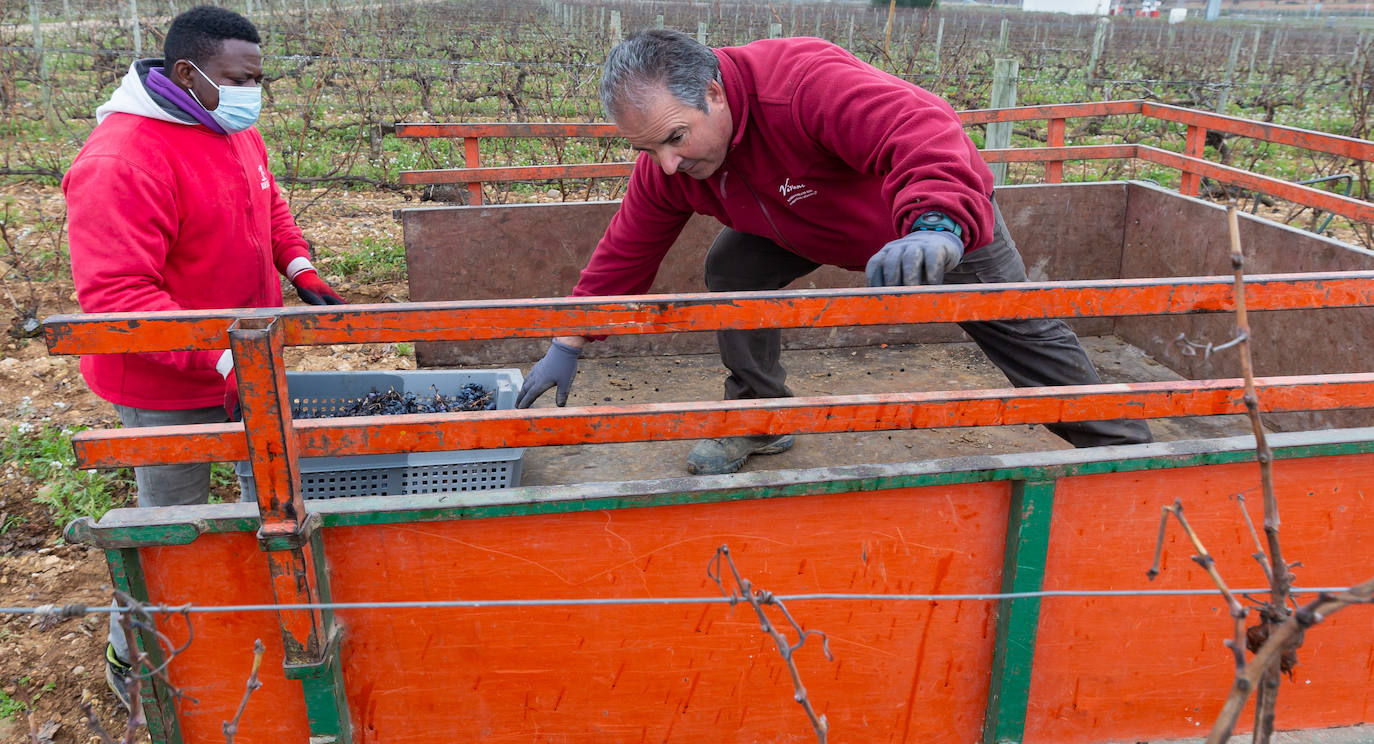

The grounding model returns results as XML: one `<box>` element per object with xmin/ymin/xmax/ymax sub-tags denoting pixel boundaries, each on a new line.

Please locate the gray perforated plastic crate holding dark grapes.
<box><xmin>234</xmin><ymin>370</ymin><xmax>525</xmax><ymax>501</ymax></box>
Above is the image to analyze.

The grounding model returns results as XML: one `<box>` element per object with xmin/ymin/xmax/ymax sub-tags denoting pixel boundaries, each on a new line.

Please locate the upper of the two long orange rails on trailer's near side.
<box><xmin>44</xmin><ymin>271</ymin><xmax>1374</xmax><ymax>353</ymax></box>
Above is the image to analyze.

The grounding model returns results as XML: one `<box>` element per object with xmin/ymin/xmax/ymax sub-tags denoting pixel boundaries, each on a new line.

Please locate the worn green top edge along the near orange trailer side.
<box><xmin>77</xmin><ymin>430</ymin><xmax>1374</xmax><ymax>547</ymax></box>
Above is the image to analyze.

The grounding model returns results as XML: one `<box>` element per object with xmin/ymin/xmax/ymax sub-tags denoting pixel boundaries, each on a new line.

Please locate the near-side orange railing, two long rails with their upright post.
<box><xmin>45</xmin><ymin>272</ymin><xmax>1374</xmax><ymax>467</ymax></box>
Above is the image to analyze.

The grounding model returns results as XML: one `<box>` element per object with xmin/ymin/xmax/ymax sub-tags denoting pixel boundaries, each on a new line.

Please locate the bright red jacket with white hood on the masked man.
<box><xmin>62</xmin><ymin>63</ymin><xmax>308</xmax><ymax>410</ymax></box>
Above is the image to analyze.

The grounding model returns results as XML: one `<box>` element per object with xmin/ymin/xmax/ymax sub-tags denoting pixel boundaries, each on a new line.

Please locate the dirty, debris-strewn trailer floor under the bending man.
<box><xmin>521</xmin><ymin>336</ymin><xmax>1250</xmax><ymax>485</ymax></box>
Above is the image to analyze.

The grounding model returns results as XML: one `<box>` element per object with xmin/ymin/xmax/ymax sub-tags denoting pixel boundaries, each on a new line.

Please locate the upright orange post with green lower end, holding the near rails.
<box><xmin>229</xmin><ymin>318</ymin><xmax>353</xmax><ymax>744</ymax></box>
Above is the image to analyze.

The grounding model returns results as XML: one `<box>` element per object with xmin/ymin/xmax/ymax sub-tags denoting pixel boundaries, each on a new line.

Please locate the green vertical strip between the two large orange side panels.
<box><xmin>982</xmin><ymin>481</ymin><xmax>1055</xmax><ymax>744</ymax></box>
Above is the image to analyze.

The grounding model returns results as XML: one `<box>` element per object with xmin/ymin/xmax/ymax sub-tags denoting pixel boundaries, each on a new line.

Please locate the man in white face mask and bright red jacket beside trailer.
<box><xmin>62</xmin><ymin>6</ymin><xmax>344</xmax><ymax>707</ymax></box>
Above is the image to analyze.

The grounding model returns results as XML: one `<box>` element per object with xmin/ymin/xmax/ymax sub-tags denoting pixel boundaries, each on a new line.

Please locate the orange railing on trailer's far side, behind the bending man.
<box><xmin>396</xmin><ymin>100</ymin><xmax>1374</xmax><ymax>213</ymax></box>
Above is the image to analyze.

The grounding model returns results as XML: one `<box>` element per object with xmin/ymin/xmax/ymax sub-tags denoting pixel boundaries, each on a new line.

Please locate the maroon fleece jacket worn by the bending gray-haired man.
<box><xmin>573</xmin><ymin>39</ymin><xmax>992</xmax><ymax>296</ymax></box>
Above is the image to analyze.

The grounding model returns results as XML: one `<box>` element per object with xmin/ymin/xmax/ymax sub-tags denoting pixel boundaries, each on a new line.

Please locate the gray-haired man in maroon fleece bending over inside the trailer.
<box><xmin>517</xmin><ymin>30</ymin><xmax>1150</xmax><ymax>474</ymax></box>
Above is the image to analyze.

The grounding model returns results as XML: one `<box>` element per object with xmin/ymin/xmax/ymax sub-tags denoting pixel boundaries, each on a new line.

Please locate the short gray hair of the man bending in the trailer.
<box><xmin>600</xmin><ymin>29</ymin><xmax>720</xmax><ymax>121</ymax></box>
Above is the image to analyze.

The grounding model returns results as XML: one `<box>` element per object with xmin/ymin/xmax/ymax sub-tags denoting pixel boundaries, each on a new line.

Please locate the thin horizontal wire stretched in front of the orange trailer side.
<box><xmin>0</xmin><ymin>586</ymin><xmax>1351</xmax><ymax>619</ymax></box>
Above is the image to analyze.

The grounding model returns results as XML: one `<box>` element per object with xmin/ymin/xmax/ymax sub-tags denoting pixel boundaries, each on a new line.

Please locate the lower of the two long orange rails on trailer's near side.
<box><xmin>71</xmin><ymin>373</ymin><xmax>1374</xmax><ymax>468</ymax></box>
